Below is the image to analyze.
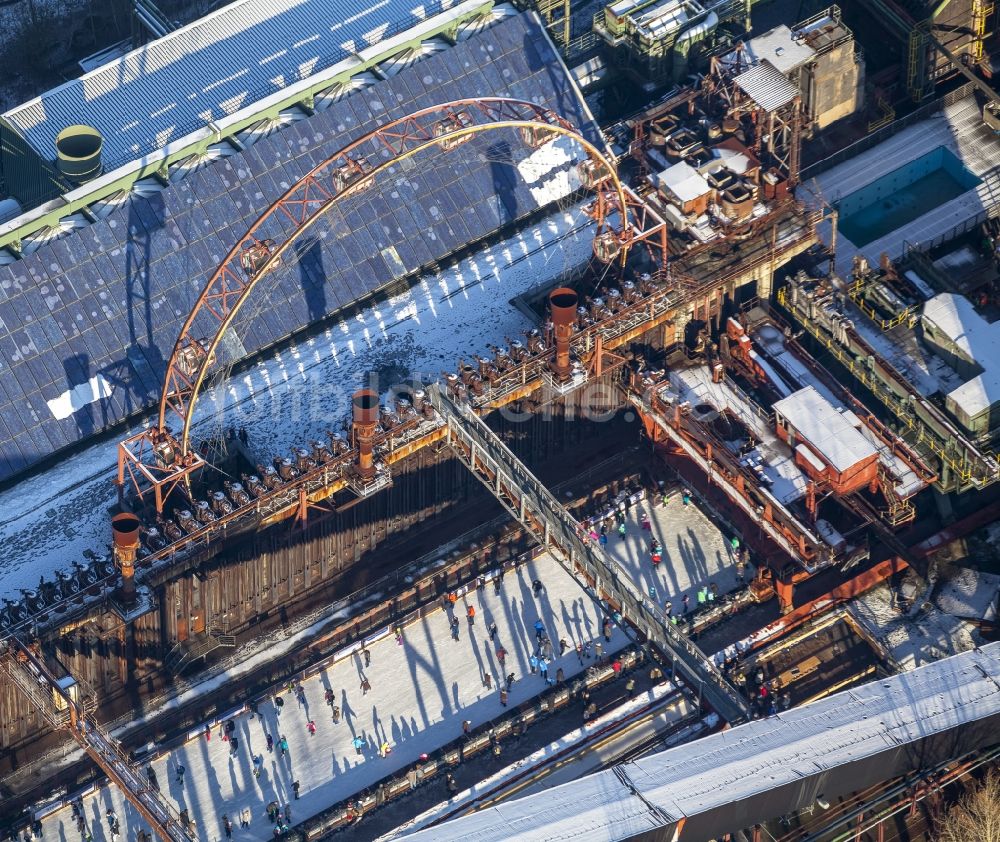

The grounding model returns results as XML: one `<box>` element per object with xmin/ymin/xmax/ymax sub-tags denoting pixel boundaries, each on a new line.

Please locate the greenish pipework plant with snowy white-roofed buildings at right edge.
<box><xmin>779</xmin><ymin>261</ymin><xmax>998</xmax><ymax>491</ymax></box>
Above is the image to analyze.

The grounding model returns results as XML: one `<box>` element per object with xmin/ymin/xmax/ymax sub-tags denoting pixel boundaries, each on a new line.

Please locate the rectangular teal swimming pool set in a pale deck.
<box><xmin>836</xmin><ymin>146</ymin><xmax>982</xmax><ymax>246</ymax></box>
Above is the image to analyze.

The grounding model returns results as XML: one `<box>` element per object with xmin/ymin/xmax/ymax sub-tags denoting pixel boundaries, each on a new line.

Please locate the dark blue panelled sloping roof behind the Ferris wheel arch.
<box><xmin>0</xmin><ymin>14</ymin><xmax>602</xmax><ymax>480</ymax></box>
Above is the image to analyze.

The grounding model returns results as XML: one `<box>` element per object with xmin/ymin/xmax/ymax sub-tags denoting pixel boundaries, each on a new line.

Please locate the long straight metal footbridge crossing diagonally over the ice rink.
<box><xmin>429</xmin><ymin>386</ymin><xmax>749</xmax><ymax>724</ymax></box>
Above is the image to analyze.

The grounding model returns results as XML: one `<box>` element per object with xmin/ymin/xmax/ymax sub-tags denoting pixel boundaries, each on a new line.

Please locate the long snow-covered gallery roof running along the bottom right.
<box><xmin>406</xmin><ymin>643</ymin><xmax>1000</xmax><ymax>842</ymax></box>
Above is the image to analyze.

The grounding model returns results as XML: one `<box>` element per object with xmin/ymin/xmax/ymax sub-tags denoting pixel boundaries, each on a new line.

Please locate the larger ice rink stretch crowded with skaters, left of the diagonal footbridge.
<box><xmin>43</xmin><ymin>556</ymin><xmax>628</xmax><ymax>842</ymax></box>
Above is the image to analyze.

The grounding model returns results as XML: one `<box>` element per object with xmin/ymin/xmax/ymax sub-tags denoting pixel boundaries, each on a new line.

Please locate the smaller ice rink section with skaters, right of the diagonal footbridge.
<box><xmin>606</xmin><ymin>494</ymin><xmax>753</xmax><ymax>614</ymax></box>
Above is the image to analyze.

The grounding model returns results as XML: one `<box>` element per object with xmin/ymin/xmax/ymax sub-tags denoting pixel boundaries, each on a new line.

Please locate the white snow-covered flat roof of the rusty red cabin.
<box><xmin>774</xmin><ymin>386</ymin><xmax>878</xmax><ymax>471</ymax></box>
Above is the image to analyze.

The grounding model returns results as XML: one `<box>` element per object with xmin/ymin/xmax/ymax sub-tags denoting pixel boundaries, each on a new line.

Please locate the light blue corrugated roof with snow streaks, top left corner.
<box><xmin>3</xmin><ymin>0</ymin><xmax>468</xmax><ymax>169</ymax></box>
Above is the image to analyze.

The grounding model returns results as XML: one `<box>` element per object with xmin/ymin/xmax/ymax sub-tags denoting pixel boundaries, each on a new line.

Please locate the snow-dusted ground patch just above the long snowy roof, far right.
<box><xmin>850</xmin><ymin>584</ymin><xmax>976</xmax><ymax>671</ymax></box>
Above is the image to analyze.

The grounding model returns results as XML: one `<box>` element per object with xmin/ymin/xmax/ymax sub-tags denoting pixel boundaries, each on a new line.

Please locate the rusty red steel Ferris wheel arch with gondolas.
<box><xmin>158</xmin><ymin>97</ymin><xmax>630</xmax><ymax>464</ymax></box>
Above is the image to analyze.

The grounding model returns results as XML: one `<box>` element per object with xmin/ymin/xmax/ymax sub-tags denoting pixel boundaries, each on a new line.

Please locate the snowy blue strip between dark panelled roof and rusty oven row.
<box><xmin>0</xmin><ymin>206</ymin><xmax>593</xmax><ymax>598</ymax></box>
